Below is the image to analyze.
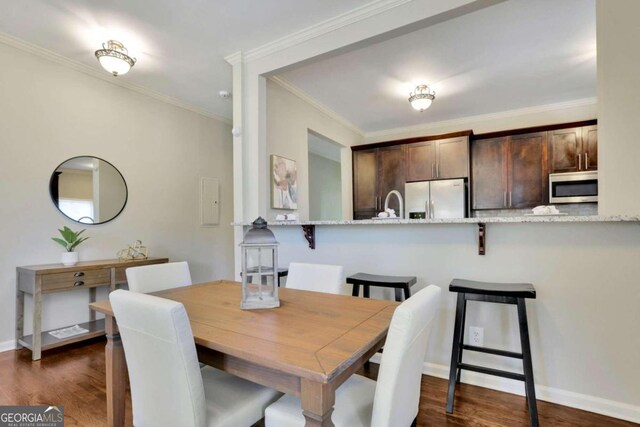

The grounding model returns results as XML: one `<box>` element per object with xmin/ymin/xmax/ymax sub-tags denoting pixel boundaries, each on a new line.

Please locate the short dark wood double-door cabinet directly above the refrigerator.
<box><xmin>406</xmin><ymin>136</ymin><xmax>469</xmax><ymax>182</ymax></box>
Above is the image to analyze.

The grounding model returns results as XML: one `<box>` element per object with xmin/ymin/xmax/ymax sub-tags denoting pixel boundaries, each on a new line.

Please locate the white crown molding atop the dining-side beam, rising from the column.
<box><xmin>242</xmin><ymin>0</ymin><xmax>412</xmax><ymax>61</ymax></box>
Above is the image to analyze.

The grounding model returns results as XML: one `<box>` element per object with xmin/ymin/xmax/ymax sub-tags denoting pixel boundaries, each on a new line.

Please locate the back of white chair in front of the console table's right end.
<box><xmin>126</xmin><ymin>261</ymin><xmax>191</xmax><ymax>294</ymax></box>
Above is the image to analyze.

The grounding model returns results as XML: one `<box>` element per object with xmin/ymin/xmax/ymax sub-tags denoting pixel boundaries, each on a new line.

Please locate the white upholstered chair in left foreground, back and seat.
<box><xmin>109</xmin><ymin>290</ymin><xmax>282</xmax><ymax>427</ymax></box>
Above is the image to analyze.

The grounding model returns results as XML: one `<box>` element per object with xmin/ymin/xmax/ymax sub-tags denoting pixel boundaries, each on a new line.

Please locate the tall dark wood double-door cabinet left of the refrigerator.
<box><xmin>353</xmin><ymin>145</ymin><xmax>405</xmax><ymax>219</ymax></box>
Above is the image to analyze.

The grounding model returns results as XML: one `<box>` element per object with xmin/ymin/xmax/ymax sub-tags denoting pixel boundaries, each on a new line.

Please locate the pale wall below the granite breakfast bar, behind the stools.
<box><xmin>271</xmin><ymin>223</ymin><xmax>640</xmax><ymax>422</ymax></box>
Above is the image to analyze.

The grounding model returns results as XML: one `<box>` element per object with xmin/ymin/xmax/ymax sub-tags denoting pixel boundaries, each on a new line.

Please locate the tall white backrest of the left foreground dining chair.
<box><xmin>109</xmin><ymin>290</ymin><xmax>206</xmax><ymax>427</ymax></box>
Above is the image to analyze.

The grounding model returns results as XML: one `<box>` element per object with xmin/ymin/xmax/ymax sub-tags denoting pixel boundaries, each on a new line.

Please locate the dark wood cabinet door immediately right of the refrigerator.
<box><xmin>471</xmin><ymin>137</ymin><xmax>508</xmax><ymax>209</ymax></box>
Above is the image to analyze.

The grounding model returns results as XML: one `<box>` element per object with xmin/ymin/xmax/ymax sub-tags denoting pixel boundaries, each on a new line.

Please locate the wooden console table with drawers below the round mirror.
<box><xmin>16</xmin><ymin>258</ymin><xmax>169</xmax><ymax>360</ymax></box>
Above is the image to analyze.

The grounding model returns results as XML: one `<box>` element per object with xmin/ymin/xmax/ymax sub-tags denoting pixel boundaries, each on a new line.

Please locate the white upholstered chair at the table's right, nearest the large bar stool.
<box><xmin>265</xmin><ymin>285</ymin><xmax>440</xmax><ymax>427</ymax></box>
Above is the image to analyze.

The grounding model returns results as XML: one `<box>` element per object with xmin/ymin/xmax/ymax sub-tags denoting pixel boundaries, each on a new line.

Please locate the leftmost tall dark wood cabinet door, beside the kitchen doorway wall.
<box><xmin>353</xmin><ymin>149</ymin><xmax>378</xmax><ymax>218</ymax></box>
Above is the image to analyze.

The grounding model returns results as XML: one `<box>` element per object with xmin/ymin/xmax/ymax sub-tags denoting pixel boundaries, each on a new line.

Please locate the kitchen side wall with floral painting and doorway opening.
<box><xmin>261</xmin><ymin>80</ymin><xmax>362</xmax><ymax>221</ymax></box>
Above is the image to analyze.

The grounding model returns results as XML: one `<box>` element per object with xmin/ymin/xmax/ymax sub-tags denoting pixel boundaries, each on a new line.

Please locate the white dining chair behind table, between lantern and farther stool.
<box><xmin>287</xmin><ymin>262</ymin><xmax>344</xmax><ymax>294</ymax></box>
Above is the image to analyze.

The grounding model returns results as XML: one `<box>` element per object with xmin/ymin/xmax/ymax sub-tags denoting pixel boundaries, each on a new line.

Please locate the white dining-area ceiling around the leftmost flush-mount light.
<box><xmin>0</xmin><ymin>0</ymin><xmax>371</xmax><ymax>118</ymax></box>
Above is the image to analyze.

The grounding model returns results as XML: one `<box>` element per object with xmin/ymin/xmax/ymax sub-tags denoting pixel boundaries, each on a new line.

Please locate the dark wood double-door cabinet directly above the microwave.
<box><xmin>549</xmin><ymin>126</ymin><xmax>598</xmax><ymax>173</ymax></box>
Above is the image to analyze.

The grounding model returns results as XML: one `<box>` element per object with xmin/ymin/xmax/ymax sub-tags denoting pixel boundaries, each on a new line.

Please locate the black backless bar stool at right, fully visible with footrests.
<box><xmin>447</xmin><ymin>279</ymin><xmax>538</xmax><ymax>426</ymax></box>
